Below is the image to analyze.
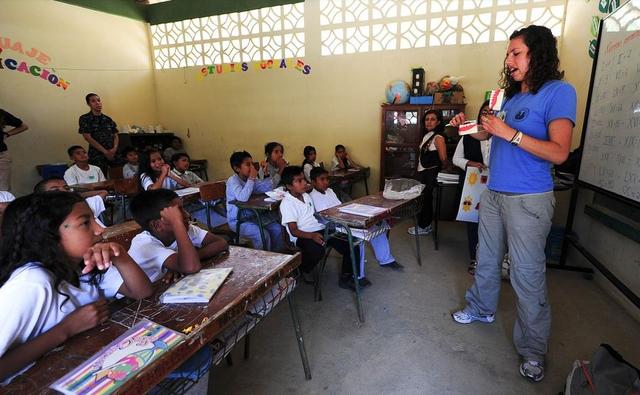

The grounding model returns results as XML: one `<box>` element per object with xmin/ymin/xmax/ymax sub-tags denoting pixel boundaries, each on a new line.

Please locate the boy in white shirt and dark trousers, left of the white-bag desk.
<box><xmin>280</xmin><ymin>166</ymin><xmax>364</xmax><ymax>290</ymax></box>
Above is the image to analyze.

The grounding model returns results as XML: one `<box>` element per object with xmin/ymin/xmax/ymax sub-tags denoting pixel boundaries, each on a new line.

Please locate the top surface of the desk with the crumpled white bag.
<box><xmin>319</xmin><ymin>192</ymin><xmax>421</xmax><ymax>229</ymax></box>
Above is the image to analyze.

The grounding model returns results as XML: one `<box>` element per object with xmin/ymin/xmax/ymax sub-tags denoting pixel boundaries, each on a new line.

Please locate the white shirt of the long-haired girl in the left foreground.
<box><xmin>0</xmin><ymin>262</ymin><xmax>124</xmax><ymax>385</ymax></box>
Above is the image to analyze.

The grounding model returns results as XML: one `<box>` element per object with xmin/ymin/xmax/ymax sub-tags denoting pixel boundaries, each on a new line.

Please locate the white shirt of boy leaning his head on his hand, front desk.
<box><xmin>129</xmin><ymin>225</ymin><xmax>207</xmax><ymax>282</ymax></box>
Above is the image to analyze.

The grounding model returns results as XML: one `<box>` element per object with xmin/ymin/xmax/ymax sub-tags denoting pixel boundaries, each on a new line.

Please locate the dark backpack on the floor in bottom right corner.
<box><xmin>564</xmin><ymin>344</ymin><xmax>640</xmax><ymax>395</ymax></box>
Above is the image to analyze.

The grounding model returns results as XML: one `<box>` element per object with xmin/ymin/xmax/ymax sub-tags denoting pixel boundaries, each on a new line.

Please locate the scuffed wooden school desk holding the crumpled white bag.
<box><xmin>319</xmin><ymin>192</ymin><xmax>422</xmax><ymax>322</ymax></box>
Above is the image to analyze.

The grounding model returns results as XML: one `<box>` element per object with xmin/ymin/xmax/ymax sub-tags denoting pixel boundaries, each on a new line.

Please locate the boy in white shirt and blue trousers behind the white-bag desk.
<box><xmin>310</xmin><ymin>167</ymin><xmax>403</xmax><ymax>278</ymax></box>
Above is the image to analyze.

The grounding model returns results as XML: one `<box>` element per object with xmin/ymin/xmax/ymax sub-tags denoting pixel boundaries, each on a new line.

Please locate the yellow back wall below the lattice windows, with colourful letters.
<box><xmin>156</xmin><ymin>1</ymin><xmax>507</xmax><ymax>189</ymax></box>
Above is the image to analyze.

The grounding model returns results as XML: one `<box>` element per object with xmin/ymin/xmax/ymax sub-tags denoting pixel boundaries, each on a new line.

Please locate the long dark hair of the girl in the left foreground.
<box><xmin>0</xmin><ymin>191</ymin><xmax>99</xmax><ymax>302</ymax></box>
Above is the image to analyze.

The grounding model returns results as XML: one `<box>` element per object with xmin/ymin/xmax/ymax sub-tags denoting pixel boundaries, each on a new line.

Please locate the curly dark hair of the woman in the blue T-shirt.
<box><xmin>500</xmin><ymin>25</ymin><xmax>564</xmax><ymax>98</ymax></box>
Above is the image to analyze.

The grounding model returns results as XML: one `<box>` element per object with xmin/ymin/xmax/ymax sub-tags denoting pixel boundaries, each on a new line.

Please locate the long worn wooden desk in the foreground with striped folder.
<box><xmin>2</xmin><ymin>246</ymin><xmax>311</xmax><ymax>395</ymax></box>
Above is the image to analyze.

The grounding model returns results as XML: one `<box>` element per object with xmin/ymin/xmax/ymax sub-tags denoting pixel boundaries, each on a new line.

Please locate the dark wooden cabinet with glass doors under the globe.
<box><xmin>380</xmin><ymin>104</ymin><xmax>465</xmax><ymax>189</ymax></box>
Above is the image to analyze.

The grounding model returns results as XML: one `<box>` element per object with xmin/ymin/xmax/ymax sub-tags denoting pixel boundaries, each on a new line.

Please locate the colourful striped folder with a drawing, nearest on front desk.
<box><xmin>51</xmin><ymin>320</ymin><xmax>184</xmax><ymax>395</ymax></box>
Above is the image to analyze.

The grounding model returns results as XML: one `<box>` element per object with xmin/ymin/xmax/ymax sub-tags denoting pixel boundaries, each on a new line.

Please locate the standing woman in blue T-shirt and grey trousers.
<box><xmin>451</xmin><ymin>25</ymin><xmax>576</xmax><ymax>381</ymax></box>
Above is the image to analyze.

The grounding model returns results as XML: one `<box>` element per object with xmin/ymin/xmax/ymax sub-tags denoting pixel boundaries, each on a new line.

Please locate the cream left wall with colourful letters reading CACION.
<box><xmin>0</xmin><ymin>0</ymin><xmax>157</xmax><ymax>195</ymax></box>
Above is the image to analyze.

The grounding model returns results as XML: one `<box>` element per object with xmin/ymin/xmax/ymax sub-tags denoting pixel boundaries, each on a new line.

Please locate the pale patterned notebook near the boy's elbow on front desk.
<box><xmin>160</xmin><ymin>267</ymin><xmax>233</xmax><ymax>303</ymax></box>
